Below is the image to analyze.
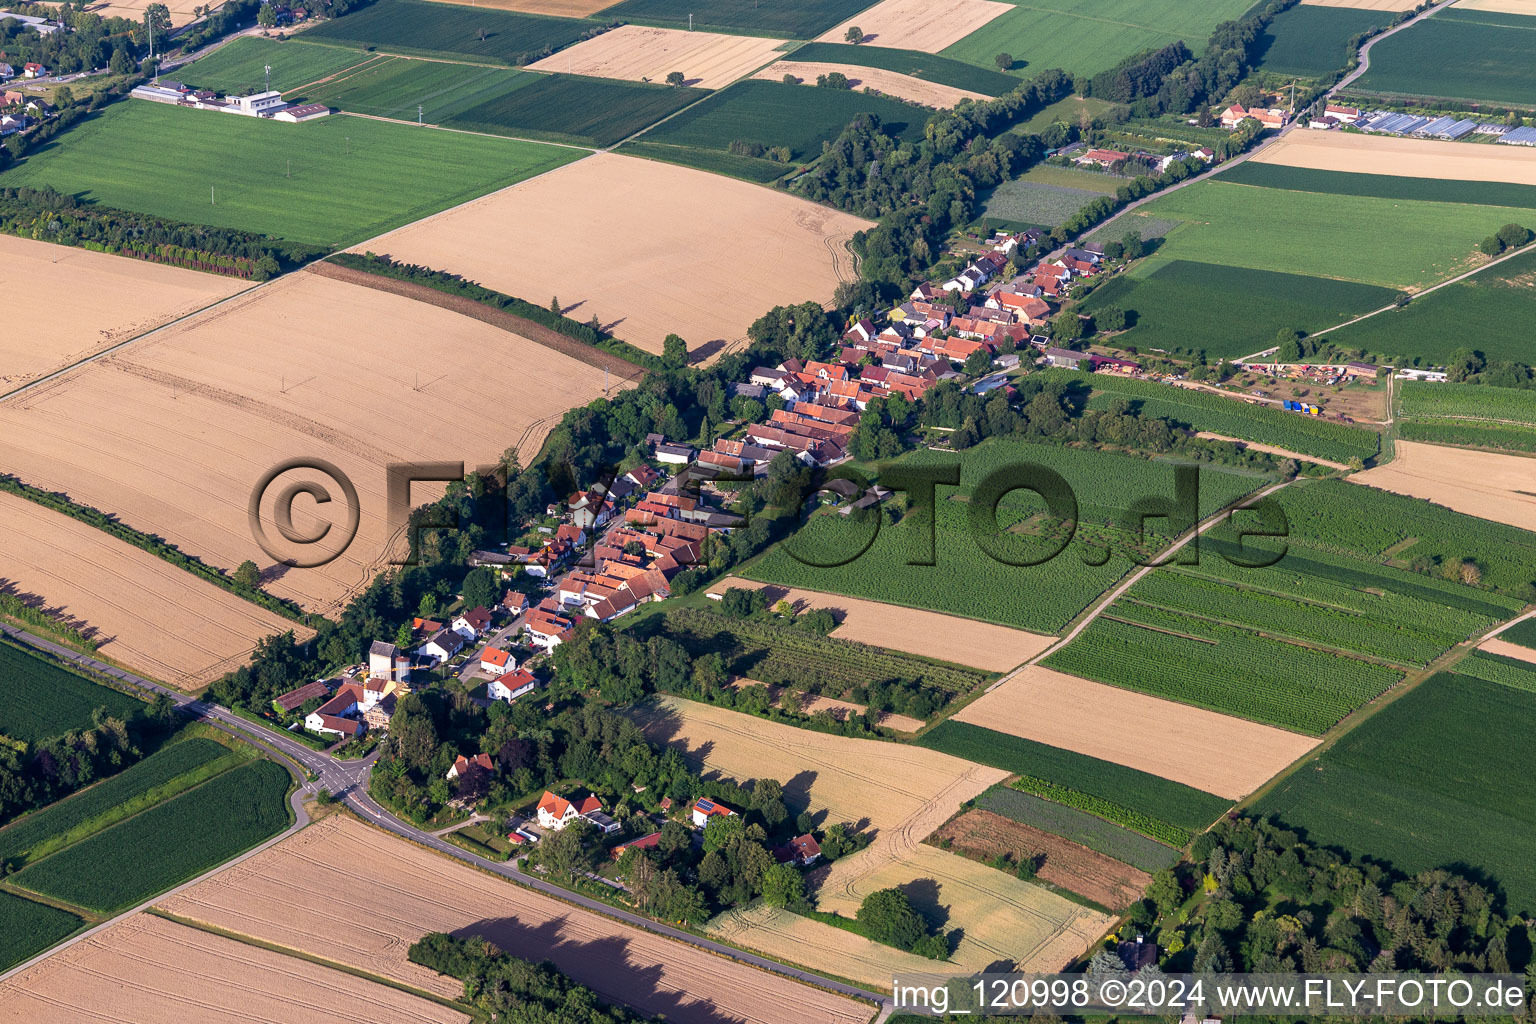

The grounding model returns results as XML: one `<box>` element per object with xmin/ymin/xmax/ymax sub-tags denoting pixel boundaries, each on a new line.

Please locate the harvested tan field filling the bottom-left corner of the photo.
<box><xmin>0</xmin><ymin>913</ymin><xmax>470</xmax><ymax>1024</ymax></box>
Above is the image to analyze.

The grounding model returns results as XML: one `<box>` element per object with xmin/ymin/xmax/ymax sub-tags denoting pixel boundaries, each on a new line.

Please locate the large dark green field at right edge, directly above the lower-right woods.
<box><xmin>1255</xmin><ymin>674</ymin><xmax>1536</xmax><ymax>913</ymax></box>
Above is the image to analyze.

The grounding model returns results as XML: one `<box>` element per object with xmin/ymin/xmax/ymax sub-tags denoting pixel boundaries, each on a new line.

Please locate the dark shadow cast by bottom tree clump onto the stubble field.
<box><xmin>452</xmin><ymin>913</ymin><xmax>746</xmax><ymax>1024</ymax></box>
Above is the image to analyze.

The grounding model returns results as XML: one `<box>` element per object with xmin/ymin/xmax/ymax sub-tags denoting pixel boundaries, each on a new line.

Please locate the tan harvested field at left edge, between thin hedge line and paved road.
<box><xmin>0</xmin><ymin>491</ymin><xmax>312</xmax><ymax>689</ymax></box>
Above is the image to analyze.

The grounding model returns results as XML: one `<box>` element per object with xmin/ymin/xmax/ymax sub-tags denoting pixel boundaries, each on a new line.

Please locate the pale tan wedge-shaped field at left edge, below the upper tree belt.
<box><xmin>0</xmin><ymin>235</ymin><xmax>250</xmax><ymax>391</ymax></box>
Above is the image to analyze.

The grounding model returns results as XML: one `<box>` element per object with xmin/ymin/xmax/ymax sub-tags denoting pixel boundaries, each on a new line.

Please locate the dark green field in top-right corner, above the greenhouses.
<box><xmin>1353</xmin><ymin>9</ymin><xmax>1536</xmax><ymax>107</ymax></box>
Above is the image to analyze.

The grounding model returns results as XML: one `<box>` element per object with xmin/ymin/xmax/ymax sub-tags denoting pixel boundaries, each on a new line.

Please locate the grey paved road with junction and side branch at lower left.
<box><xmin>0</xmin><ymin>623</ymin><xmax>886</xmax><ymax>1007</ymax></box>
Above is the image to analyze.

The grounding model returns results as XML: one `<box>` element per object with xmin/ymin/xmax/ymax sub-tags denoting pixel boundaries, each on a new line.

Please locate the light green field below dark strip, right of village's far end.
<box><xmin>1144</xmin><ymin>178</ymin><xmax>1531</xmax><ymax>289</ymax></box>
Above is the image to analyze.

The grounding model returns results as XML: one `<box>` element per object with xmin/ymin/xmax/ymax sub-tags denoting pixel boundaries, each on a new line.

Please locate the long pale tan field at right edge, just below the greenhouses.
<box><xmin>1253</xmin><ymin>130</ymin><xmax>1536</xmax><ymax>184</ymax></box>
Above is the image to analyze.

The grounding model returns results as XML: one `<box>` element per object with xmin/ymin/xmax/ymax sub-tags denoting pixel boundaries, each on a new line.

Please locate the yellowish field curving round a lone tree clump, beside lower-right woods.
<box><xmin>816</xmin><ymin>843</ymin><xmax>1114</xmax><ymax>972</ymax></box>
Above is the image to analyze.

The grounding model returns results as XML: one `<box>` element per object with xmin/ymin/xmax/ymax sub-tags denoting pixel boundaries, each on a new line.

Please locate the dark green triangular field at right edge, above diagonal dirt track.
<box><xmin>1329</xmin><ymin>247</ymin><xmax>1536</xmax><ymax>365</ymax></box>
